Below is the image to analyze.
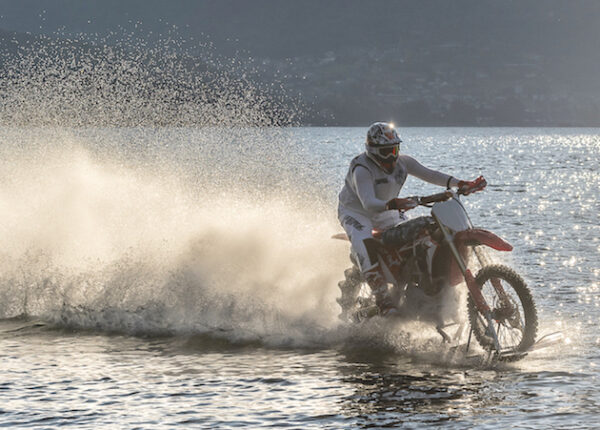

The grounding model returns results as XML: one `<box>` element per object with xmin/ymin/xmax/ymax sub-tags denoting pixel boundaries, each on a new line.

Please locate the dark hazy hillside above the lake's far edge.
<box><xmin>0</xmin><ymin>0</ymin><xmax>600</xmax><ymax>126</ymax></box>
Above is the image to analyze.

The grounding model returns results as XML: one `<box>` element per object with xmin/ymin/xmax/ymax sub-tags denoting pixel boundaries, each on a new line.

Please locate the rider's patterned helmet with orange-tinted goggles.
<box><xmin>365</xmin><ymin>122</ymin><xmax>402</xmax><ymax>173</ymax></box>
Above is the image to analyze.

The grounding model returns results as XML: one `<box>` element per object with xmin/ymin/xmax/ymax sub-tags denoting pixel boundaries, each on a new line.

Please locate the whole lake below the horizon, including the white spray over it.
<box><xmin>0</xmin><ymin>128</ymin><xmax>600</xmax><ymax>429</ymax></box>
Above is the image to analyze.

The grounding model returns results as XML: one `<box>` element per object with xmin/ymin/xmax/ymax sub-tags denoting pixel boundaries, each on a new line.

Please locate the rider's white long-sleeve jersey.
<box><xmin>339</xmin><ymin>153</ymin><xmax>458</xmax><ymax>219</ymax></box>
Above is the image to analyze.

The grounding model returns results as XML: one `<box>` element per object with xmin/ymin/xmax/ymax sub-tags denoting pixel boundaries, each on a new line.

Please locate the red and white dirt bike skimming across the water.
<box><xmin>334</xmin><ymin>185</ymin><xmax>538</xmax><ymax>360</ymax></box>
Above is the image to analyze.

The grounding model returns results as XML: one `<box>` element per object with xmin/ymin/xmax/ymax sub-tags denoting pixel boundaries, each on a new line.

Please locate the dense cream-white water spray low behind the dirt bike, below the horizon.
<box><xmin>0</xmin><ymin>130</ymin><xmax>347</xmax><ymax>346</ymax></box>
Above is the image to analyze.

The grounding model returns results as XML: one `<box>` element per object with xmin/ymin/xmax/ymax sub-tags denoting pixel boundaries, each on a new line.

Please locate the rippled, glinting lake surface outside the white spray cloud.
<box><xmin>0</xmin><ymin>128</ymin><xmax>600</xmax><ymax>429</ymax></box>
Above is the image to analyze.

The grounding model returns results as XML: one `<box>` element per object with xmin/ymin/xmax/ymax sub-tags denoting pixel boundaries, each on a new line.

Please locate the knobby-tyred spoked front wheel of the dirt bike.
<box><xmin>467</xmin><ymin>265</ymin><xmax>538</xmax><ymax>352</ymax></box>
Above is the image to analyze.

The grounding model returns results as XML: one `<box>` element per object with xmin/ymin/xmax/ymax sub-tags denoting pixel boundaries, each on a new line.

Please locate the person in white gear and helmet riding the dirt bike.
<box><xmin>338</xmin><ymin>122</ymin><xmax>483</xmax><ymax>315</ymax></box>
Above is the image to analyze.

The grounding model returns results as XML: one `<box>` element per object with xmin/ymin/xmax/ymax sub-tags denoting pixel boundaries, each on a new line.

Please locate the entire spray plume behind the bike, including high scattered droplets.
<box><xmin>0</xmin><ymin>29</ymin><xmax>347</xmax><ymax>346</ymax></box>
